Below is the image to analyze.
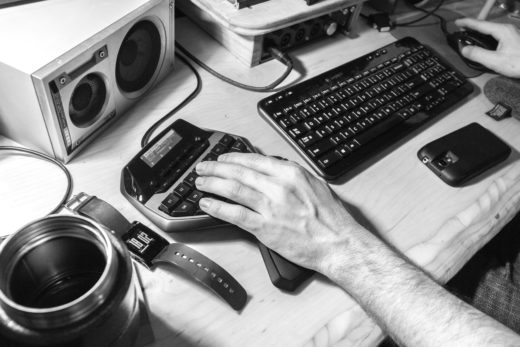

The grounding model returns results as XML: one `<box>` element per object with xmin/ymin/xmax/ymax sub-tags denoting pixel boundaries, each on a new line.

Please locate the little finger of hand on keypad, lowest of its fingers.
<box><xmin>199</xmin><ymin>198</ymin><xmax>262</xmax><ymax>232</ymax></box>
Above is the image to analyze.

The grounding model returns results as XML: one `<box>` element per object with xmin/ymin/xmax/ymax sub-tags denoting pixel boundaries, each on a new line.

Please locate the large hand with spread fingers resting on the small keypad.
<box><xmin>195</xmin><ymin>153</ymin><xmax>362</xmax><ymax>273</ymax></box>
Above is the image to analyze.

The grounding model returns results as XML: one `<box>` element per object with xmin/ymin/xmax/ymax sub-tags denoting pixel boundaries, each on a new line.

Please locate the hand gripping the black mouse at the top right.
<box><xmin>455</xmin><ymin>18</ymin><xmax>520</xmax><ymax>78</ymax></box>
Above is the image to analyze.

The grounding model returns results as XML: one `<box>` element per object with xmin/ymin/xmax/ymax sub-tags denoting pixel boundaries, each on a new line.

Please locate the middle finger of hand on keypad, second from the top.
<box><xmin>195</xmin><ymin>161</ymin><xmax>271</xmax><ymax>190</ymax></box>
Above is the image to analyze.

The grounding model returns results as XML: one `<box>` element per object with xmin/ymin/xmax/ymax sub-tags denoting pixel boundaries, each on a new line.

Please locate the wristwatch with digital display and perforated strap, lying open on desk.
<box><xmin>65</xmin><ymin>193</ymin><xmax>247</xmax><ymax>311</ymax></box>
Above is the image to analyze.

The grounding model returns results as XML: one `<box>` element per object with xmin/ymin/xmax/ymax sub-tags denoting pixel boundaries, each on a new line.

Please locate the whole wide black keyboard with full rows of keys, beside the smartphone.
<box><xmin>258</xmin><ymin>37</ymin><xmax>473</xmax><ymax>180</ymax></box>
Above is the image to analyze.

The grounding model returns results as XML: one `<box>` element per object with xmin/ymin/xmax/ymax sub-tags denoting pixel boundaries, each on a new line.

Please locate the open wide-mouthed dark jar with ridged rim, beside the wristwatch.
<box><xmin>0</xmin><ymin>215</ymin><xmax>139</xmax><ymax>347</ymax></box>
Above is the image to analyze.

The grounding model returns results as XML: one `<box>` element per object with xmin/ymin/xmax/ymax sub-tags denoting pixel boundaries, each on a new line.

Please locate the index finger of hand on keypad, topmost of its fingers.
<box><xmin>213</xmin><ymin>153</ymin><xmax>288</xmax><ymax>176</ymax></box>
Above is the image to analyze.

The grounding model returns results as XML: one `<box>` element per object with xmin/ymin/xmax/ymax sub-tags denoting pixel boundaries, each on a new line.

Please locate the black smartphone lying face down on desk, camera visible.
<box><xmin>417</xmin><ymin>123</ymin><xmax>511</xmax><ymax>187</ymax></box>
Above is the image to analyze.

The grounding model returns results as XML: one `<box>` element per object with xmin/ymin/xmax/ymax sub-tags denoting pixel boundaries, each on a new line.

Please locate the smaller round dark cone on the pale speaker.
<box><xmin>69</xmin><ymin>73</ymin><xmax>107</xmax><ymax>128</ymax></box>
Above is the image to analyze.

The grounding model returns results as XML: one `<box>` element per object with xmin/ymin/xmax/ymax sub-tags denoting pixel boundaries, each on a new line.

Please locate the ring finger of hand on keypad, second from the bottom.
<box><xmin>195</xmin><ymin>176</ymin><xmax>265</xmax><ymax>211</ymax></box>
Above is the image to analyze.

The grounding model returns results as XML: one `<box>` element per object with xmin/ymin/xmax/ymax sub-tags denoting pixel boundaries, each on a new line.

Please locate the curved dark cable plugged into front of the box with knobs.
<box><xmin>175</xmin><ymin>42</ymin><xmax>293</xmax><ymax>92</ymax></box>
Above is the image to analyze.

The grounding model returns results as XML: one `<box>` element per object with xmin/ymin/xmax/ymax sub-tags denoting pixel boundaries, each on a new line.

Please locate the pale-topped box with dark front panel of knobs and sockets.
<box><xmin>176</xmin><ymin>0</ymin><xmax>366</xmax><ymax>66</ymax></box>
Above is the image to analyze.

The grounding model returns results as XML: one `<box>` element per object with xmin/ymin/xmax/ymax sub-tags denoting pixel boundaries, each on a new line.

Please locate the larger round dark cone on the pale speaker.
<box><xmin>116</xmin><ymin>20</ymin><xmax>161</xmax><ymax>93</ymax></box>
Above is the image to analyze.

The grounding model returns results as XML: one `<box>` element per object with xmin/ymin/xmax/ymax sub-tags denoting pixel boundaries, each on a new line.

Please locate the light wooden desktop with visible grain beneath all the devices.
<box><xmin>0</xmin><ymin>2</ymin><xmax>520</xmax><ymax>347</ymax></box>
